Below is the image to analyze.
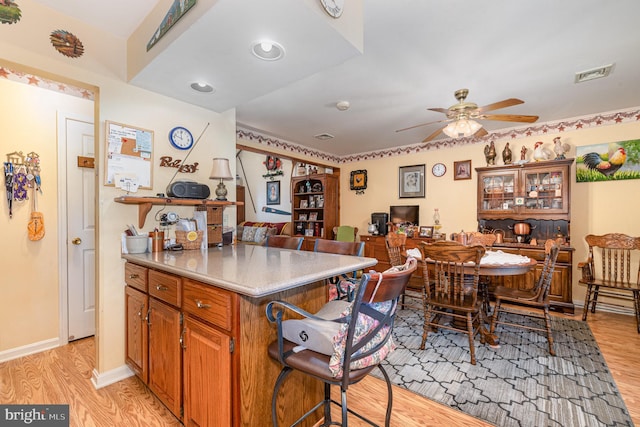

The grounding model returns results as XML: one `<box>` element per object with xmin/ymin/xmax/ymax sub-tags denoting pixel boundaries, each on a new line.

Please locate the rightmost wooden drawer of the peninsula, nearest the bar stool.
<box><xmin>182</xmin><ymin>279</ymin><xmax>236</xmax><ymax>331</ymax></box>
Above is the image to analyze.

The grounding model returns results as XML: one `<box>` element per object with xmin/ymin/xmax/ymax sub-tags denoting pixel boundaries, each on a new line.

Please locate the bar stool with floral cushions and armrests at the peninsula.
<box><xmin>266</xmin><ymin>258</ymin><xmax>417</xmax><ymax>427</ymax></box>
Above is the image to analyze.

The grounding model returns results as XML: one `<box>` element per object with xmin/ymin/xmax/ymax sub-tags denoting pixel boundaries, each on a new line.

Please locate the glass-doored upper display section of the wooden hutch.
<box><xmin>476</xmin><ymin>159</ymin><xmax>573</xmax><ymax>221</ymax></box>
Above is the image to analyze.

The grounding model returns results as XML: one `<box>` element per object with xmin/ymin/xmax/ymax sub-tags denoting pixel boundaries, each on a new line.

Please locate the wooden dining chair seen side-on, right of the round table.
<box><xmin>490</xmin><ymin>239</ymin><xmax>559</xmax><ymax>356</ymax></box>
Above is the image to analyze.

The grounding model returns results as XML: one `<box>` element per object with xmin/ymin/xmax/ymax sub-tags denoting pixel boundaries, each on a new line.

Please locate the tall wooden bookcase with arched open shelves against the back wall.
<box><xmin>291</xmin><ymin>174</ymin><xmax>340</xmax><ymax>239</ymax></box>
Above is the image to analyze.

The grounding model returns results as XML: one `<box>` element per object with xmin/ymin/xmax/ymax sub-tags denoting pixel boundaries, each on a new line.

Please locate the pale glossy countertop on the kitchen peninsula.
<box><xmin>122</xmin><ymin>245</ymin><xmax>378</xmax><ymax>297</ymax></box>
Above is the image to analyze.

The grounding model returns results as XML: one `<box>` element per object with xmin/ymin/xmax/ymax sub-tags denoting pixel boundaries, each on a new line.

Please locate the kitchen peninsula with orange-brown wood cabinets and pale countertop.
<box><xmin>122</xmin><ymin>245</ymin><xmax>377</xmax><ymax>426</ymax></box>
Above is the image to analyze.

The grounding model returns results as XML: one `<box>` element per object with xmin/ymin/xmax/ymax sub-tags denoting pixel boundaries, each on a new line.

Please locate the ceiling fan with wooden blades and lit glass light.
<box><xmin>396</xmin><ymin>89</ymin><xmax>538</xmax><ymax>142</ymax></box>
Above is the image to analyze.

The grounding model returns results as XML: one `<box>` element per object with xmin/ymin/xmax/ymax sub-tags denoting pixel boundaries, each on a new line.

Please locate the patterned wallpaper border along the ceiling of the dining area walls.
<box><xmin>236</xmin><ymin>107</ymin><xmax>640</xmax><ymax>163</ymax></box>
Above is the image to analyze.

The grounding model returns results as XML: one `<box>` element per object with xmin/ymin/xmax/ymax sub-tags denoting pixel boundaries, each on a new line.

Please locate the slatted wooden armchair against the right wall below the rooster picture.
<box><xmin>578</xmin><ymin>233</ymin><xmax>640</xmax><ymax>333</ymax></box>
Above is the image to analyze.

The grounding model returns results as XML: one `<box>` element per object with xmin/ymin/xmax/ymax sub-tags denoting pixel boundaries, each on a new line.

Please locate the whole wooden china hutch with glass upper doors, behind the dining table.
<box><xmin>476</xmin><ymin>159</ymin><xmax>574</xmax><ymax>313</ymax></box>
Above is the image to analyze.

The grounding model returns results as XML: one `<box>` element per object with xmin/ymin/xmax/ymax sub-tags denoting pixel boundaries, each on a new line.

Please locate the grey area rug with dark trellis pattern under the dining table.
<box><xmin>374</xmin><ymin>309</ymin><xmax>633</xmax><ymax>427</ymax></box>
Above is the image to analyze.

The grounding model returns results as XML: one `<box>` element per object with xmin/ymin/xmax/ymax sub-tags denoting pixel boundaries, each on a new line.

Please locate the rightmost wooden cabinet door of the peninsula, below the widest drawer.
<box><xmin>183</xmin><ymin>316</ymin><xmax>233</xmax><ymax>427</ymax></box>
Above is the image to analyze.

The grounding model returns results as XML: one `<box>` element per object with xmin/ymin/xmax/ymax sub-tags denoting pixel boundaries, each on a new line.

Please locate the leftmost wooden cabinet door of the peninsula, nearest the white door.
<box><xmin>125</xmin><ymin>286</ymin><xmax>149</xmax><ymax>384</ymax></box>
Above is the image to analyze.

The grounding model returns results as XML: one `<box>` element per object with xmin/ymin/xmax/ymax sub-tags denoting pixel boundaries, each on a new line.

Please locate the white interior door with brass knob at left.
<box><xmin>60</xmin><ymin>116</ymin><xmax>96</xmax><ymax>341</ymax></box>
